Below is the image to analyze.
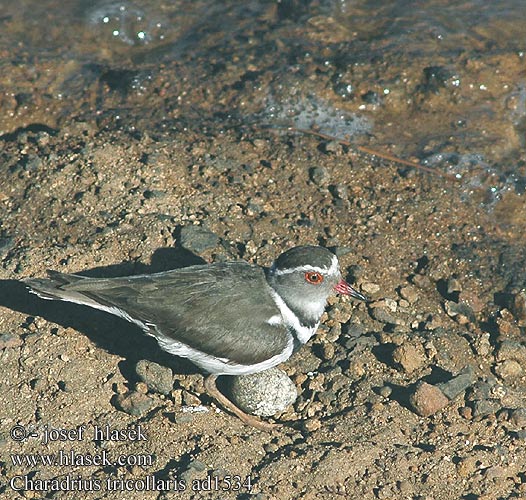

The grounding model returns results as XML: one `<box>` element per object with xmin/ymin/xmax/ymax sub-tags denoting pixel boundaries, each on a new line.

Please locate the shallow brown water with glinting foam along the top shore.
<box><xmin>0</xmin><ymin>0</ymin><xmax>526</xmax><ymax>206</ymax></box>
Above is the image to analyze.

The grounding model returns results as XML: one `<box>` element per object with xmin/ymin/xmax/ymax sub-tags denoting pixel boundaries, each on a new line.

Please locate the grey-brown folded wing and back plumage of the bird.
<box><xmin>32</xmin><ymin>262</ymin><xmax>290</xmax><ymax>364</ymax></box>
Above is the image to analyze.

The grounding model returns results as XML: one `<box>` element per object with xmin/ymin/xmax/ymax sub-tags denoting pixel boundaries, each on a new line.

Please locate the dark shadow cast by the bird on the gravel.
<box><xmin>0</xmin><ymin>248</ymin><xmax>210</xmax><ymax>381</ymax></box>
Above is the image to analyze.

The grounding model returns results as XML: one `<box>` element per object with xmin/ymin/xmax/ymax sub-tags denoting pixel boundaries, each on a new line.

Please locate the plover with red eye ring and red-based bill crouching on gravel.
<box><xmin>24</xmin><ymin>245</ymin><xmax>368</xmax><ymax>431</ymax></box>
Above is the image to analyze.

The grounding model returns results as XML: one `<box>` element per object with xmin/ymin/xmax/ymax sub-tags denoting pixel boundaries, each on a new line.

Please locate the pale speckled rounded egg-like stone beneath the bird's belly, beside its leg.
<box><xmin>231</xmin><ymin>368</ymin><xmax>298</xmax><ymax>417</ymax></box>
